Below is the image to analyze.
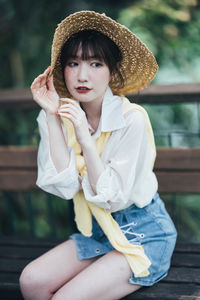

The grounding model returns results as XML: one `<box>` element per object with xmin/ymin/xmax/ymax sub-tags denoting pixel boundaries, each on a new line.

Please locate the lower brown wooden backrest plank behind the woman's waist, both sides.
<box><xmin>0</xmin><ymin>146</ymin><xmax>200</xmax><ymax>194</ymax></box>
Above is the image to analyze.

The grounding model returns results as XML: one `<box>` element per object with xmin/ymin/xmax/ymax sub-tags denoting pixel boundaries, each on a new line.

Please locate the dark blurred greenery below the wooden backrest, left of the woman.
<box><xmin>0</xmin><ymin>190</ymin><xmax>76</xmax><ymax>238</ymax></box>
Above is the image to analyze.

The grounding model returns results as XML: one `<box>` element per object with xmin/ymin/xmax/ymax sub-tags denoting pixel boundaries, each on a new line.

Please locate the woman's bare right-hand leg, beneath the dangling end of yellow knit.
<box><xmin>52</xmin><ymin>250</ymin><xmax>141</xmax><ymax>300</ymax></box>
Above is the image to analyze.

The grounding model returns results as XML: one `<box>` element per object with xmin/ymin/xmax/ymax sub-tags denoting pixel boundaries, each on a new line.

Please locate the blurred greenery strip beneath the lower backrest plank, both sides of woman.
<box><xmin>0</xmin><ymin>190</ymin><xmax>200</xmax><ymax>242</ymax></box>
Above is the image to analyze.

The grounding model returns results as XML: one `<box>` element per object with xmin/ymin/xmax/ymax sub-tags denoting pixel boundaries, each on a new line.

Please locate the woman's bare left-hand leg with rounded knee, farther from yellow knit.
<box><xmin>20</xmin><ymin>240</ymin><xmax>95</xmax><ymax>300</ymax></box>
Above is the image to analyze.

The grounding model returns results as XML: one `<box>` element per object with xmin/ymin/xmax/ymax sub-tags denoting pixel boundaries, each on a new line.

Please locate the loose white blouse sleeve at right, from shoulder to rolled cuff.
<box><xmin>82</xmin><ymin>110</ymin><xmax>157</xmax><ymax>211</ymax></box>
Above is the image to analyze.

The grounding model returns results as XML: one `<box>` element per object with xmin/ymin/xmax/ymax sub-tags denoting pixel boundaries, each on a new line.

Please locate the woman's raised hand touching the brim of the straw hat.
<box><xmin>31</xmin><ymin>67</ymin><xmax>59</xmax><ymax>114</ymax></box>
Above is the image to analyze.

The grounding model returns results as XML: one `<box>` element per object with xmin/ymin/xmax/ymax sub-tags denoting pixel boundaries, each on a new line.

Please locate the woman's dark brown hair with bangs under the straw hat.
<box><xmin>60</xmin><ymin>30</ymin><xmax>124</xmax><ymax>87</ymax></box>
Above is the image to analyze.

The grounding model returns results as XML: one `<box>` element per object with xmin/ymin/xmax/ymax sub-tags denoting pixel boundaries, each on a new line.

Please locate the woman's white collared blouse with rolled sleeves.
<box><xmin>36</xmin><ymin>88</ymin><xmax>158</xmax><ymax>212</ymax></box>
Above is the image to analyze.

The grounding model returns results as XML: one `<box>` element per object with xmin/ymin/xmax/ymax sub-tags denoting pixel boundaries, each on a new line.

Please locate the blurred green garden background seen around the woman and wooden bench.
<box><xmin>0</xmin><ymin>0</ymin><xmax>200</xmax><ymax>241</ymax></box>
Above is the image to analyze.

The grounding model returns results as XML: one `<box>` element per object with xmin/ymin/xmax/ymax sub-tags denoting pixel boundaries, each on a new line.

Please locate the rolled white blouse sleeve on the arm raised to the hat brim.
<box><xmin>36</xmin><ymin>110</ymin><xmax>80</xmax><ymax>199</ymax></box>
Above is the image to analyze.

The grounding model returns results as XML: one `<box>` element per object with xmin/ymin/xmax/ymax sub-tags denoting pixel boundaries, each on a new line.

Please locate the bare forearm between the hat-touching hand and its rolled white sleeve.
<box><xmin>46</xmin><ymin>113</ymin><xmax>69</xmax><ymax>173</ymax></box>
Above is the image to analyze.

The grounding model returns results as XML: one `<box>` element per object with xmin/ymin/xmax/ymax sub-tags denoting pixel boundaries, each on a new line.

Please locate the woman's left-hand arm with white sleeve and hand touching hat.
<box><xmin>31</xmin><ymin>67</ymin><xmax>80</xmax><ymax>199</ymax></box>
